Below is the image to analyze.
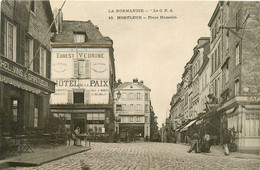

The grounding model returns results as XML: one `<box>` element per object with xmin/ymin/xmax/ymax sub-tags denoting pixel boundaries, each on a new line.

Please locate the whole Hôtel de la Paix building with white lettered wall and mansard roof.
<box><xmin>51</xmin><ymin>12</ymin><xmax>115</xmax><ymax>138</ymax></box>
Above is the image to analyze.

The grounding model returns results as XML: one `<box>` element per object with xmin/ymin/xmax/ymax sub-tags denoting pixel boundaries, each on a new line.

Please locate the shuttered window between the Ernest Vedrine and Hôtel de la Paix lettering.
<box><xmin>73</xmin><ymin>60</ymin><xmax>91</xmax><ymax>78</ymax></box>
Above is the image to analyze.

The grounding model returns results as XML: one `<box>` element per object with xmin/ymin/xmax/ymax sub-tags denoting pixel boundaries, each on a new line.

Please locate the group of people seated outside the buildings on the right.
<box><xmin>188</xmin><ymin>132</ymin><xmax>210</xmax><ymax>153</ymax></box>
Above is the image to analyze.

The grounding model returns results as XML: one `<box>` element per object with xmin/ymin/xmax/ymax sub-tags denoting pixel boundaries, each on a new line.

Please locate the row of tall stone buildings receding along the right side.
<box><xmin>171</xmin><ymin>1</ymin><xmax>260</xmax><ymax>152</ymax></box>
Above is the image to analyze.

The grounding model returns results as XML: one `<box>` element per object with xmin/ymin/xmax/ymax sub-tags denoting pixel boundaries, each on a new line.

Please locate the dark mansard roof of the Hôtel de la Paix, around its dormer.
<box><xmin>52</xmin><ymin>20</ymin><xmax>113</xmax><ymax>45</ymax></box>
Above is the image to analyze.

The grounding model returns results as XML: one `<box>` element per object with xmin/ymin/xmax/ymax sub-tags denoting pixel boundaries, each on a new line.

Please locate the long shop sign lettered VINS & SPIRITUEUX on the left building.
<box><xmin>0</xmin><ymin>56</ymin><xmax>55</xmax><ymax>92</ymax></box>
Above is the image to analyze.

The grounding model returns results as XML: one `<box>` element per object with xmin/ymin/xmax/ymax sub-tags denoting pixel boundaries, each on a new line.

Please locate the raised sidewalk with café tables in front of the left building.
<box><xmin>0</xmin><ymin>145</ymin><xmax>91</xmax><ymax>169</ymax></box>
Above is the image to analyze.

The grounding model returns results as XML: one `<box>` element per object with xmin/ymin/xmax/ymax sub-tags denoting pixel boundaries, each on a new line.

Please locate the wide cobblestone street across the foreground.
<box><xmin>9</xmin><ymin>143</ymin><xmax>260</xmax><ymax>170</ymax></box>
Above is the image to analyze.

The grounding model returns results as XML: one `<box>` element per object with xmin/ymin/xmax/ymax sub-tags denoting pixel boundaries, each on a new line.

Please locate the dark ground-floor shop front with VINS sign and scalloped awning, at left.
<box><xmin>0</xmin><ymin>57</ymin><xmax>55</xmax><ymax>135</ymax></box>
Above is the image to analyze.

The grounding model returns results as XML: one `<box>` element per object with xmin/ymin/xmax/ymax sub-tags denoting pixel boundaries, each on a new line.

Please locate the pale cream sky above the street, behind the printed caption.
<box><xmin>50</xmin><ymin>0</ymin><xmax>217</xmax><ymax>127</ymax></box>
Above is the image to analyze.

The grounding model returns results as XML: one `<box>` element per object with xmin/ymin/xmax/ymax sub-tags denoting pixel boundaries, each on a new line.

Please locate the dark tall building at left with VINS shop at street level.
<box><xmin>0</xmin><ymin>1</ymin><xmax>56</xmax><ymax>135</ymax></box>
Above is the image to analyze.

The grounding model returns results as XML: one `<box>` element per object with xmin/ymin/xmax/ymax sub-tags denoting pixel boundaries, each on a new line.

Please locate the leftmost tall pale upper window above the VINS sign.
<box><xmin>4</xmin><ymin>21</ymin><xmax>16</xmax><ymax>61</ymax></box>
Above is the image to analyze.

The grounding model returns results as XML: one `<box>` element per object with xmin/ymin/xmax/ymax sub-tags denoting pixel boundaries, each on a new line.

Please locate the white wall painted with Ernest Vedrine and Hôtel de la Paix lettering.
<box><xmin>51</xmin><ymin>48</ymin><xmax>110</xmax><ymax>104</ymax></box>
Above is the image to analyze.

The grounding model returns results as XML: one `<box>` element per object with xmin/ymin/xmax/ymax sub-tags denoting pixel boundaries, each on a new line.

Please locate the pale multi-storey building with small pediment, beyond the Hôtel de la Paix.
<box><xmin>114</xmin><ymin>79</ymin><xmax>151</xmax><ymax>140</ymax></box>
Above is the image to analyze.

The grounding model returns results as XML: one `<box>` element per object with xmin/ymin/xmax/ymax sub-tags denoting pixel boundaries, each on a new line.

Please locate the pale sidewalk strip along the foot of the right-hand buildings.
<box><xmin>183</xmin><ymin>144</ymin><xmax>260</xmax><ymax>159</ymax></box>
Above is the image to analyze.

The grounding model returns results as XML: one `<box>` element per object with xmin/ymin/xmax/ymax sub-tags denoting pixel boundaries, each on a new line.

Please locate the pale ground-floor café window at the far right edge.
<box><xmin>245</xmin><ymin>113</ymin><xmax>260</xmax><ymax>136</ymax></box>
